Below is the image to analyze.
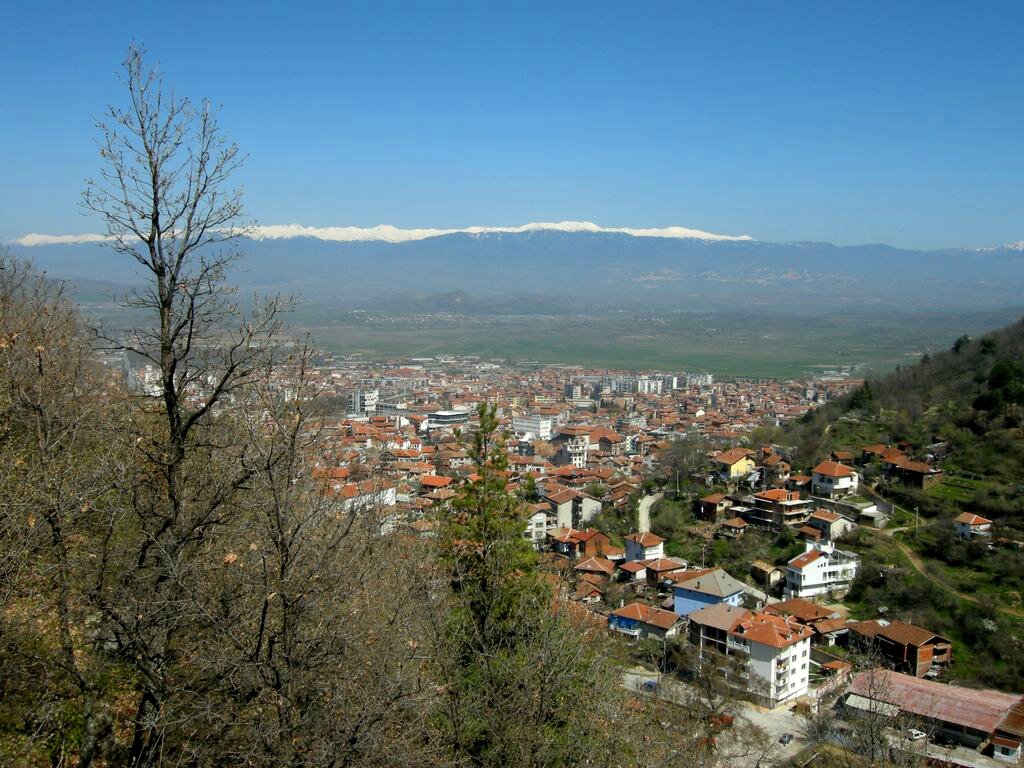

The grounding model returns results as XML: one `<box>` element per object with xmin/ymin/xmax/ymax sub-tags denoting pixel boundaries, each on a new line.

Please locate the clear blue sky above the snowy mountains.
<box><xmin>0</xmin><ymin>0</ymin><xmax>1024</xmax><ymax>248</ymax></box>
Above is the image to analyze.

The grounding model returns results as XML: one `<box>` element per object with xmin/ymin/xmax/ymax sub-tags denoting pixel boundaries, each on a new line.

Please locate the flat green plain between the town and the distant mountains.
<box><xmin>297</xmin><ymin>310</ymin><xmax>1016</xmax><ymax>378</ymax></box>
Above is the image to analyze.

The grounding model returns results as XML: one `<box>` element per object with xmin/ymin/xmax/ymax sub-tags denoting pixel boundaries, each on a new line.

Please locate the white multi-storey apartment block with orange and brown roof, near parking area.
<box><xmin>689</xmin><ymin>603</ymin><xmax>813</xmax><ymax>708</ymax></box>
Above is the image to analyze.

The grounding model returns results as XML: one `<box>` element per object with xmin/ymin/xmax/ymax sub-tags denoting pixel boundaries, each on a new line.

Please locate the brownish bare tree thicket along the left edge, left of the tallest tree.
<box><xmin>0</xmin><ymin>253</ymin><xmax>121</xmax><ymax>766</ymax></box>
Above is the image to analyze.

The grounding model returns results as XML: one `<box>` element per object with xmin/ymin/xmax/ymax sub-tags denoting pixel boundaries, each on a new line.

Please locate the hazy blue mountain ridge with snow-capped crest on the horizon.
<box><xmin>11</xmin><ymin>228</ymin><xmax>1024</xmax><ymax>311</ymax></box>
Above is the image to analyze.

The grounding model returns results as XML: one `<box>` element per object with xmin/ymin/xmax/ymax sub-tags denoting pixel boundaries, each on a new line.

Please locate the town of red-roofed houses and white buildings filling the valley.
<box><xmin>121</xmin><ymin>355</ymin><xmax>1024</xmax><ymax>768</ymax></box>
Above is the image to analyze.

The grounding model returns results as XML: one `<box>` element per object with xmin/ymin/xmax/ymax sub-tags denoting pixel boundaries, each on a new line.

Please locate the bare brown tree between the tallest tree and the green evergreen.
<box><xmin>186</xmin><ymin>347</ymin><xmax>432</xmax><ymax>766</ymax></box>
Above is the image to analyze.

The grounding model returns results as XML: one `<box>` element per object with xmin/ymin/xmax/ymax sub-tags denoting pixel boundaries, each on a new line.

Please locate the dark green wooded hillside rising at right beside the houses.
<box><xmin>778</xmin><ymin>321</ymin><xmax>1024</xmax><ymax>691</ymax></box>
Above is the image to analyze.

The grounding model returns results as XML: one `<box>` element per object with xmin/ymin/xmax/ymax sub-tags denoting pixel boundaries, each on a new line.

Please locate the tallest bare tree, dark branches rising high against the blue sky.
<box><xmin>83</xmin><ymin>47</ymin><xmax>282</xmax><ymax>766</ymax></box>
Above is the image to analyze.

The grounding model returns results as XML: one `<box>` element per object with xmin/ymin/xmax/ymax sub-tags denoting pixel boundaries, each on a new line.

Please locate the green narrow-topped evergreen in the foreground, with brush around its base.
<box><xmin>435</xmin><ymin>406</ymin><xmax>634</xmax><ymax>766</ymax></box>
